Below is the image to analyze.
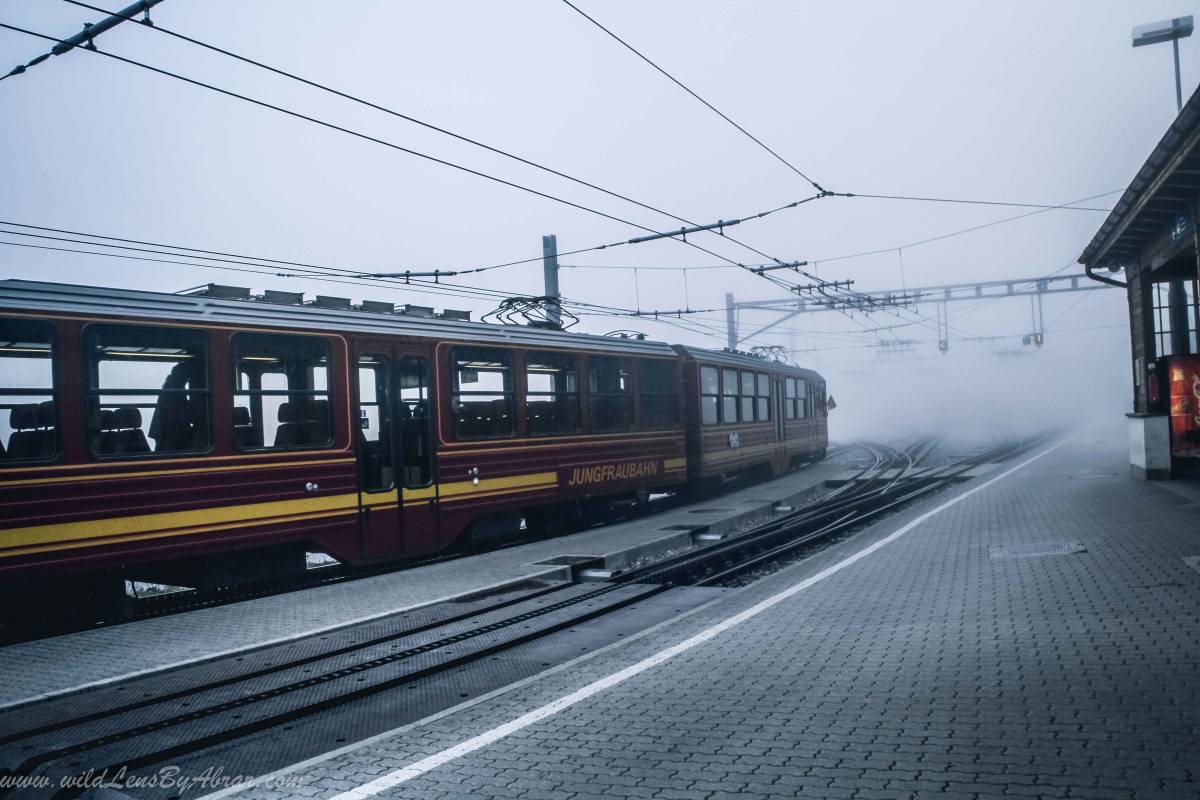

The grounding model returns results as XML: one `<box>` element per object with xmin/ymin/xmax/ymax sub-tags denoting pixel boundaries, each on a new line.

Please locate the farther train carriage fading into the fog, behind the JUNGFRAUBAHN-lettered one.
<box><xmin>674</xmin><ymin>344</ymin><xmax>829</xmax><ymax>486</ymax></box>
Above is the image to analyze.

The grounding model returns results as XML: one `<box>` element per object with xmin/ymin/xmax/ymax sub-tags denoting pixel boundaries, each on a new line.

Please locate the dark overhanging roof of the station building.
<box><xmin>1079</xmin><ymin>80</ymin><xmax>1200</xmax><ymax>267</ymax></box>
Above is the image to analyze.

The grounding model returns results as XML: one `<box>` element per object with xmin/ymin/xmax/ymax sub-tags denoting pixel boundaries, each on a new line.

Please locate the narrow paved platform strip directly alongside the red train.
<box><xmin>0</xmin><ymin>459</ymin><xmax>846</xmax><ymax>709</ymax></box>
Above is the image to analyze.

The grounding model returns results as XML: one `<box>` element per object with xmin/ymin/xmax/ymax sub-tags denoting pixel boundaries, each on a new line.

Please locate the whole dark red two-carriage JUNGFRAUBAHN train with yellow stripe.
<box><xmin>0</xmin><ymin>281</ymin><xmax>827</xmax><ymax>599</ymax></box>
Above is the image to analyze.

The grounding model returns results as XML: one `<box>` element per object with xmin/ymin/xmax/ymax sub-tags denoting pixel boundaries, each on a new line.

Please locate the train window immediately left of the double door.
<box><xmin>233</xmin><ymin>333</ymin><xmax>332</xmax><ymax>450</ymax></box>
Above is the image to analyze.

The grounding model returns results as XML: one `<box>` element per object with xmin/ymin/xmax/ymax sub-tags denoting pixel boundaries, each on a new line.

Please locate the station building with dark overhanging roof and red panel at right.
<box><xmin>1079</xmin><ymin>89</ymin><xmax>1200</xmax><ymax>480</ymax></box>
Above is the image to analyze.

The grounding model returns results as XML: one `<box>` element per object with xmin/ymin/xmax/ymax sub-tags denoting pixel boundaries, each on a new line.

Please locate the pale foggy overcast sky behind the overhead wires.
<box><xmin>0</xmin><ymin>0</ymin><xmax>1200</xmax><ymax>431</ymax></box>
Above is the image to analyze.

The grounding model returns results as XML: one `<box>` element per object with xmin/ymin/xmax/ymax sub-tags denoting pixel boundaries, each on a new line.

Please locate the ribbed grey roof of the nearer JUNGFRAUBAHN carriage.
<box><xmin>0</xmin><ymin>278</ymin><xmax>676</xmax><ymax>356</ymax></box>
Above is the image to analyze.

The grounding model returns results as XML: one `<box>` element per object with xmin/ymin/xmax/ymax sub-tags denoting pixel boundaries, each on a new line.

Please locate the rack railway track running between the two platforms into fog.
<box><xmin>0</xmin><ymin>440</ymin><xmax>1036</xmax><ymax>800</ymax></box>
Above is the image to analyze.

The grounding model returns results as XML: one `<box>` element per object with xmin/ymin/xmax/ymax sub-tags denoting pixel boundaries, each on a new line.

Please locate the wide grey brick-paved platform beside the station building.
<box><xmin>218</xmin><ymin>432</ymin><xmax>1200</xmax><ymax>800</ymax></box>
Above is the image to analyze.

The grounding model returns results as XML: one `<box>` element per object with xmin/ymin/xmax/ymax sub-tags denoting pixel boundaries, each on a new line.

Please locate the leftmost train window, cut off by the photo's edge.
<box><xmin>0</xmin><ymin>319</ymin><xmax>59</xmax><ymax>467</ymax></box>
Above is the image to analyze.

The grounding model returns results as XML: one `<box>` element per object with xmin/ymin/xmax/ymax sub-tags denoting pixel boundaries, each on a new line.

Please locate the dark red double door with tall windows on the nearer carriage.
<box><xmin>354</xmin><ymin>343</ymin><xmax>438</xmax><ymax>559</ymax></box>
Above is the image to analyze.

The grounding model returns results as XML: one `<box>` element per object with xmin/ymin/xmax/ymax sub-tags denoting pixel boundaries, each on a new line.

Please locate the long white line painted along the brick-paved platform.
<box><xmin>314</xmin><ymin>439</ymin><xmax>1067</xmax><ymax>800</ymax></box>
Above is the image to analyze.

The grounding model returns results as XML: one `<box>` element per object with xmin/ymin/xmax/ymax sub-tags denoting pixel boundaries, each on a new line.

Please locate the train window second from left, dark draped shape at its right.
<box><xmin>84</xmin><ymin>325</ymin><xmax>211</xmax><ymax>457</ymax></box>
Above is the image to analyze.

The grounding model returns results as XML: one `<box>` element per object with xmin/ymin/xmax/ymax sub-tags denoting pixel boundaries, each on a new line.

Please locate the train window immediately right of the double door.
<box><xmin>450</xmin><ymin>347</ymin><xmax>515</xmax><ymax>439</ymax></box>
